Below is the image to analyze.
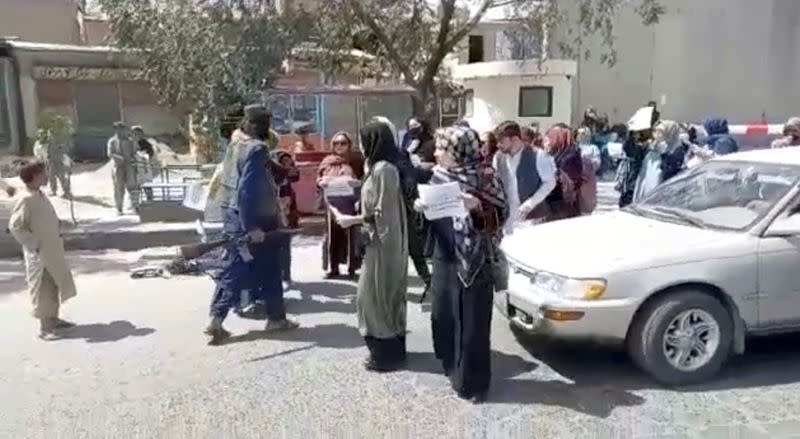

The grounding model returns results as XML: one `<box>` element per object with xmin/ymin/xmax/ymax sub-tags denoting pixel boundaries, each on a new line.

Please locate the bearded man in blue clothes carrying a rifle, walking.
<box><xmin>205</xmin><ymin>105</ymin><xmax>298</xmax><ymax>345</ymax></box>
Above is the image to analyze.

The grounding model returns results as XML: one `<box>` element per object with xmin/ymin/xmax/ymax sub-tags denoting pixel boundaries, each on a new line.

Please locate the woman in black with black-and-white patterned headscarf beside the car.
<box><xmin>422</xmin><ymin>127</ymin><xmax>508</xmax><ymax>402</ymax></box>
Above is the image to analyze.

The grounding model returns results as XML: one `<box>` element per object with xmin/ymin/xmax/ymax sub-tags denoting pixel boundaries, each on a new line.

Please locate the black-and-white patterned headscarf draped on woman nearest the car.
<box><xmin>435</xmin><ymin>126</ymin><xmax>508</xmax><ymax>287</ymax></box>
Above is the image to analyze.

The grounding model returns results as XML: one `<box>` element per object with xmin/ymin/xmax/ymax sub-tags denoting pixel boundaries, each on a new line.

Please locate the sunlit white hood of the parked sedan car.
<box><xmin>501</xmin><ymin>211</ymin><xmax>737</xmax><ymax>278</ymax></box>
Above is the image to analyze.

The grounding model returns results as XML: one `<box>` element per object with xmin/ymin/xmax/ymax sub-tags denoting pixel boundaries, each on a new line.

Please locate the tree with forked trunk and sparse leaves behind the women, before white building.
<box><xmin>306</xmin><ymin>0</ymin><xmax>664</xmax><ymax>118</ymax></box>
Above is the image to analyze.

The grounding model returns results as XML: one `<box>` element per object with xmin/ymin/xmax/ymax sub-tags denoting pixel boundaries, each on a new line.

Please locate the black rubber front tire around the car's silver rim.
<box><xmin>628</xmin><ymin>290</ymin><xmax>734</xmax><ymax>385</ymax></box>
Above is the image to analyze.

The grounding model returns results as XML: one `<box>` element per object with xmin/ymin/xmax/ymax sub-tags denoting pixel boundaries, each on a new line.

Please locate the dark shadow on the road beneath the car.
<box><xmin>518</xmin><ymin>334</ymin><xmax>800</xmax><ymax>392</ymax></box>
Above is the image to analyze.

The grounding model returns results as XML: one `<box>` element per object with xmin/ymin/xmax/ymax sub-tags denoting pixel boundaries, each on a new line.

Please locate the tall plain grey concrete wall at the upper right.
<box><xmin>551</xmin><ymin>0</ymin><xmax>800</xmax><ymax>123</ymax></box>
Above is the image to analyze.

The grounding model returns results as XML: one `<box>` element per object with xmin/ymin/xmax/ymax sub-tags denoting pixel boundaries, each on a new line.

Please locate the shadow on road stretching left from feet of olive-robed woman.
<box><xmin>225</xmin><ymin>324</ymin><xmax>363</xmax><ymax>350</ymax></box>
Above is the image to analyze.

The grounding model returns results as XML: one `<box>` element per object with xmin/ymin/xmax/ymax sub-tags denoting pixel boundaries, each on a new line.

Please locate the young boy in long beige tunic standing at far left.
<box><xmin>8</xmin><ymin>162</ymin><xmax>77</xmax><ymax>341</ymax></box>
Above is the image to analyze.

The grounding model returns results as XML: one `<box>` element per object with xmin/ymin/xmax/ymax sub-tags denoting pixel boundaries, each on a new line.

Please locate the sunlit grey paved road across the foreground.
<box><xmin>0</xmin><ymin>184</ymin><xmax>800</xmax><ymax>439</ymax></box>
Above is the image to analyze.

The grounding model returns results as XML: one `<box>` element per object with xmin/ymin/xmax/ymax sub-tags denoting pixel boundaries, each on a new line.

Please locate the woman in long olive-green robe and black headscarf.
<box><xmin>331</xmin><ymin>122</ymin><xmax>408</xmax><ymax>372</ymax></box>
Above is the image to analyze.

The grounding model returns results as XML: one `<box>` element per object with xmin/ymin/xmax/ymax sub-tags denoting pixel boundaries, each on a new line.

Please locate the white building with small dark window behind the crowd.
<box><xmin>449</xmin><ymin>8</ymin><xmax>577</xmax><ymax>131</ymax></box>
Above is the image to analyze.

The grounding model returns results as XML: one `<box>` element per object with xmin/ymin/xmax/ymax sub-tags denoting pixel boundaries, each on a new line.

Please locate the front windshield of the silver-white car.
<box><xmin>628</xmin><ymin>160</ymin><xmax>800</xmax><ymax>231</ymax></box>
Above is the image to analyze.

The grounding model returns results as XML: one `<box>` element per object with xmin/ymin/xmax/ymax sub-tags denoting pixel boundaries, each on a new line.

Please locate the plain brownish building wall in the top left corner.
<box><xmin>0</xmin><ymin>0</ymin><xmax>80</xmax><ymax>44</ymax></box>
